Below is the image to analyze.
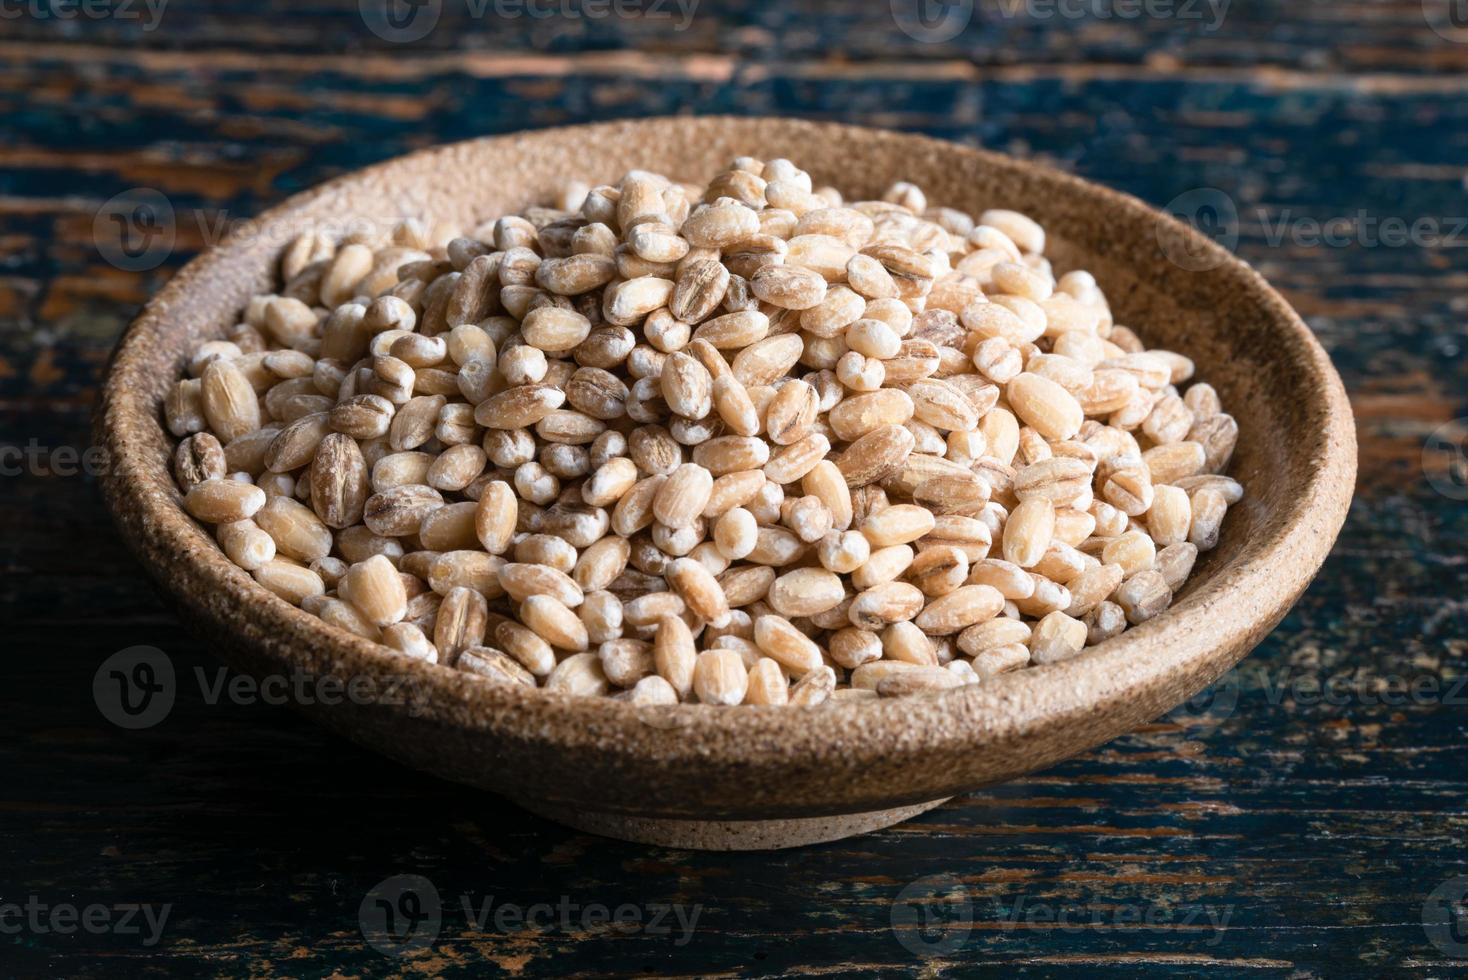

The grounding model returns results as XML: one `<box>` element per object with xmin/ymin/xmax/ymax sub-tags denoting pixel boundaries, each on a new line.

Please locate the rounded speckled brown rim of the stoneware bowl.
<box><xmin>97</xmin><ymin>116</ymin><xmax>1355</xmax><ymax>786</ymax></box>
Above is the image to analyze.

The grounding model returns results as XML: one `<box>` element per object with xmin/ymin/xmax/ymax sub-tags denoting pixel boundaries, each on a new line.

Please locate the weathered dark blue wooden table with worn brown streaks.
<box><xmin>0</xmin><ymin>0</ymin><xmax>1468</xmax><ymax>977</ymax></box>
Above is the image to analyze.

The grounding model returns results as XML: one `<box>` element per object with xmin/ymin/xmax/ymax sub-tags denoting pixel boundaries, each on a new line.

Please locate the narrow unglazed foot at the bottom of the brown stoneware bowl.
<box><xmin>515</xmin><ymin>797</ymin><xmax>951</xmax><ymax>851</ymax></box>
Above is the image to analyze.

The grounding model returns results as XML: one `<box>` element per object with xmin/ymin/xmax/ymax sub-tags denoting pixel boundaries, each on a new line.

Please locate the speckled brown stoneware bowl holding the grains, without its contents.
<box><xmin>98</xmin><ymin>117</ymin><xmax>1356</xmax><ymax>848</ymax></box>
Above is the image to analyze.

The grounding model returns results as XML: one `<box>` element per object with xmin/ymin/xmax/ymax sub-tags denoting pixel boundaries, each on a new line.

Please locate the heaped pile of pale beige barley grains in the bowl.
<box><xmin>166</xmin><ymin>157</ymin><xmax>1242</xmax><ymax>704</ymax></box>
